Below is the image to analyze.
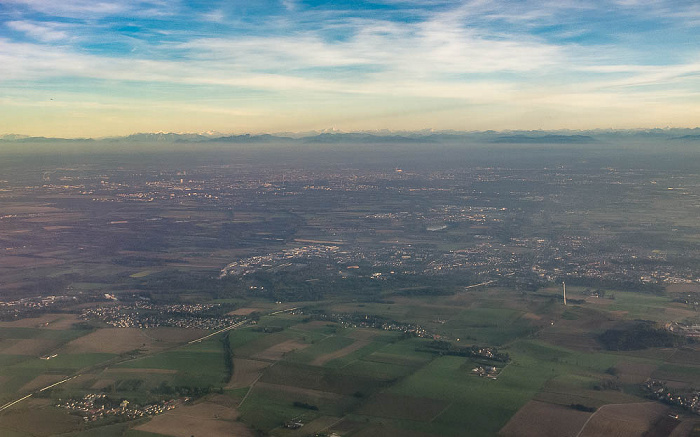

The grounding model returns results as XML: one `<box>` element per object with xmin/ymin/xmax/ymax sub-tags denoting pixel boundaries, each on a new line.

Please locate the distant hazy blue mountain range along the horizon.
<box><xmin>0</xmin><ymin>128</ymin><xmax>700</xmax><ymax>144</ymax></box>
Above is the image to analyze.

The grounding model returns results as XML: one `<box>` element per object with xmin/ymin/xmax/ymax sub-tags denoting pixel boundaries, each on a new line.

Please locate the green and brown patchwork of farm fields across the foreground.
<box><xmin>0</xmin><ymin>289</ymin><xmax>700</xmax><ymax>437</ymax></box>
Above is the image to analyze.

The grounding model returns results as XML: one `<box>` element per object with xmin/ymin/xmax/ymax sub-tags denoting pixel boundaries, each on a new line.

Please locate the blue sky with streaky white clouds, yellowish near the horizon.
<box><xmin>0</xmin><ymin>0</ymin><xmax>700</xmax><ymax>137</ymax></box>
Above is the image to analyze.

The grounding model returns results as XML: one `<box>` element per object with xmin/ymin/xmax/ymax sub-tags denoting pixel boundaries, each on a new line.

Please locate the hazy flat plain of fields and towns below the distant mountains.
<box><xmin>0</xmin><ymin>141</ymin><xmax>700</xmax><ymax>437</ymax></box>
